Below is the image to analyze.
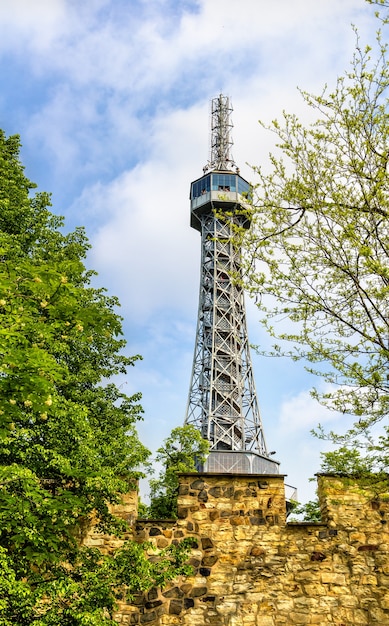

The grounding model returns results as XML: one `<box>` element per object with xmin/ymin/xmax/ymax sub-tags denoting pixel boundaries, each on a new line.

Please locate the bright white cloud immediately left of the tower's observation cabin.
<box><xmin>83</xmin><ymin>102</ymin><xmax>206</xmax><ymax>319</ymax></box>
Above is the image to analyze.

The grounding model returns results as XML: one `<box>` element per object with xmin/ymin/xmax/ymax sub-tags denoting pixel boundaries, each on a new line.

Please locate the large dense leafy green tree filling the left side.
<box><xmin>0</xmin><ymin>132</ymin><xmax>192</xmax><ymax>626</ymax></box>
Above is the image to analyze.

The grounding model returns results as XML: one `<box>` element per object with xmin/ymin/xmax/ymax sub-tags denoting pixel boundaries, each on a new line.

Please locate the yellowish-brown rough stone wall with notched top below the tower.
<box><xmin>87</xmin><ymin>474</ymin><xmax>389</xmax><ymax>626</ymax></box>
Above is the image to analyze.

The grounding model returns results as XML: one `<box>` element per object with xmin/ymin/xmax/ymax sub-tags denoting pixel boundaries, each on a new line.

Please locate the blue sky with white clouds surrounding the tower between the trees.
<box><xmin>0</xmin><ymin>0</ymin><xmax>377</xmax><ymax>501</ymax></box>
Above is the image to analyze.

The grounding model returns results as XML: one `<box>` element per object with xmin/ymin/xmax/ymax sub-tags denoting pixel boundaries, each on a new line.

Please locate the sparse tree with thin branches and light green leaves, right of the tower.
<box><xmin>241</xmin><ymin>19</ymin><xmax>389</xmax><ymax>454</ymax></box>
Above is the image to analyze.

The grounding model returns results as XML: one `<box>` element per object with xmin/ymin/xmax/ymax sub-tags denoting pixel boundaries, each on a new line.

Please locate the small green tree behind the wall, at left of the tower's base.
<box><xmin>146</xmin><ymin>424</ymin><xmax>209</xmax><ymax>519</ymax></box>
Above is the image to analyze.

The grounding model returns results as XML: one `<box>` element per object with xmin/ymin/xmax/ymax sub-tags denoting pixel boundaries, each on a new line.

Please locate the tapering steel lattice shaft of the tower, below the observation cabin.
<box><xmin>186</xmin><ymin>215</ymin><xmax>267</xmax><ymax>456</ymax></box>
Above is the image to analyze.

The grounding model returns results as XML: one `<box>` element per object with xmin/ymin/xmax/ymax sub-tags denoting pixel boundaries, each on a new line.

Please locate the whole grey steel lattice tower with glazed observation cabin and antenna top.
<box><xmin>185</xmin><ymin>95</ymin><xmax>279</xmax><ymax>474</ymax></box>
